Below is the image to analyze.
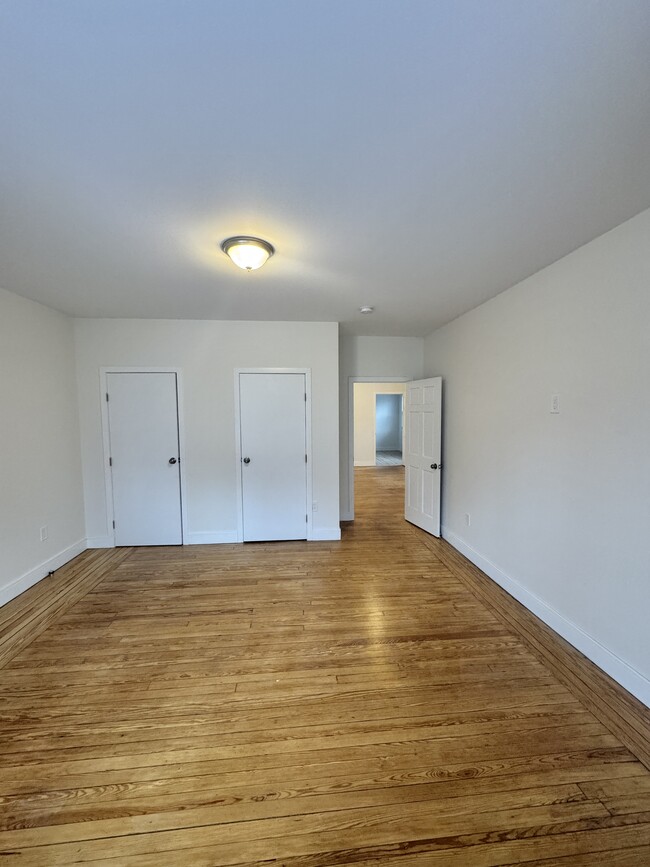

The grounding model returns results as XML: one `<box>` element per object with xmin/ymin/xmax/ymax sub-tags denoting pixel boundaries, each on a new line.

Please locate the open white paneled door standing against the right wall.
<box><xmin>404</xmin><ymin>376</ymin><xmax>442</xmax><ymax>536</ymax></box>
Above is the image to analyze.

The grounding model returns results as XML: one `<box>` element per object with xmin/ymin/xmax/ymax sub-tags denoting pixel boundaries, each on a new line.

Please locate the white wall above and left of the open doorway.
<box><xmin>339</xmin><ymin>335</ymin><xmax>424</xmax><ymax>521</ymax></box>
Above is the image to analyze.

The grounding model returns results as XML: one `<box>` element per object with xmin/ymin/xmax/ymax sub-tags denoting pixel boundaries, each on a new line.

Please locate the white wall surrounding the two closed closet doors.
<box><xmin>75</xmin><ymin>319</ymin><xmax>339</xmax><ymax>546</ymax></box>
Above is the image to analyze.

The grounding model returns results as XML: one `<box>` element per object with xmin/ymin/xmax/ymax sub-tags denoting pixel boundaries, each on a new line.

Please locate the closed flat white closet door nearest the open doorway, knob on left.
<box><xmin>239</xmin><ymin>373</ymin><xmax>307</xmax><ymax>542</ymax></box>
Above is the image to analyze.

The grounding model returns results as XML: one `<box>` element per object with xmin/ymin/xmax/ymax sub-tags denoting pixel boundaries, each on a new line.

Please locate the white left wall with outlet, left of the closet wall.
<box><xmin>0</xmin><ymin>290</ymin><xmax>86</xmax><ymax>605</ymax></box>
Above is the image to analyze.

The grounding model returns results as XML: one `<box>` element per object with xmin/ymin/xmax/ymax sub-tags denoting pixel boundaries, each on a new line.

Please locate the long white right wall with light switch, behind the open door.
<box><xmin>425</xmin><ymin>211</ymin><xmax>650</xmax><ymax>704</ymax></box>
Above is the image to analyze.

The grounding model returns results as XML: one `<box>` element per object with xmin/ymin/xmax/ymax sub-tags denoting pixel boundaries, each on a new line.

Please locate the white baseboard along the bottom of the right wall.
<box><xmin>442</xmin><ymin>527</ymin><xmax>650</xmax><ymax>707</ymax></box>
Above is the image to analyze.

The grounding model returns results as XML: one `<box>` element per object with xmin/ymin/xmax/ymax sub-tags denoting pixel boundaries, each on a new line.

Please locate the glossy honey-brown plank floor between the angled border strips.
<box><xmin>0</xmin><ymin>468</ymin><xmax>650</xmax><ymax>867</ymax></box>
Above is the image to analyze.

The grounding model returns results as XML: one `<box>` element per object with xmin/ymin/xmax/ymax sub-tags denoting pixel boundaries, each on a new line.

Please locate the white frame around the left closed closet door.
<box><xmin>99</xmin><ymin>367</ymin><xmax>187</xmax><ymax>548</ymax></box>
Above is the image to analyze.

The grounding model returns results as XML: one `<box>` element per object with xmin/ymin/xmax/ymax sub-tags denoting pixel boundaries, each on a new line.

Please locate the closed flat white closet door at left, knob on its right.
<box><xmin>106</xmin><ymin>373</ymin><xmax>183</xmax><ymax>545</ymax></box>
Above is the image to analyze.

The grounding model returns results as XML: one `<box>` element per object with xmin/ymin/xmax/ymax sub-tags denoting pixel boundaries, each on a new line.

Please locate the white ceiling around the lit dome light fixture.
<box><xmin>0</xmin><ymin>0</ymin><xmax>650</xmax><ymax>336</ymax></box>
